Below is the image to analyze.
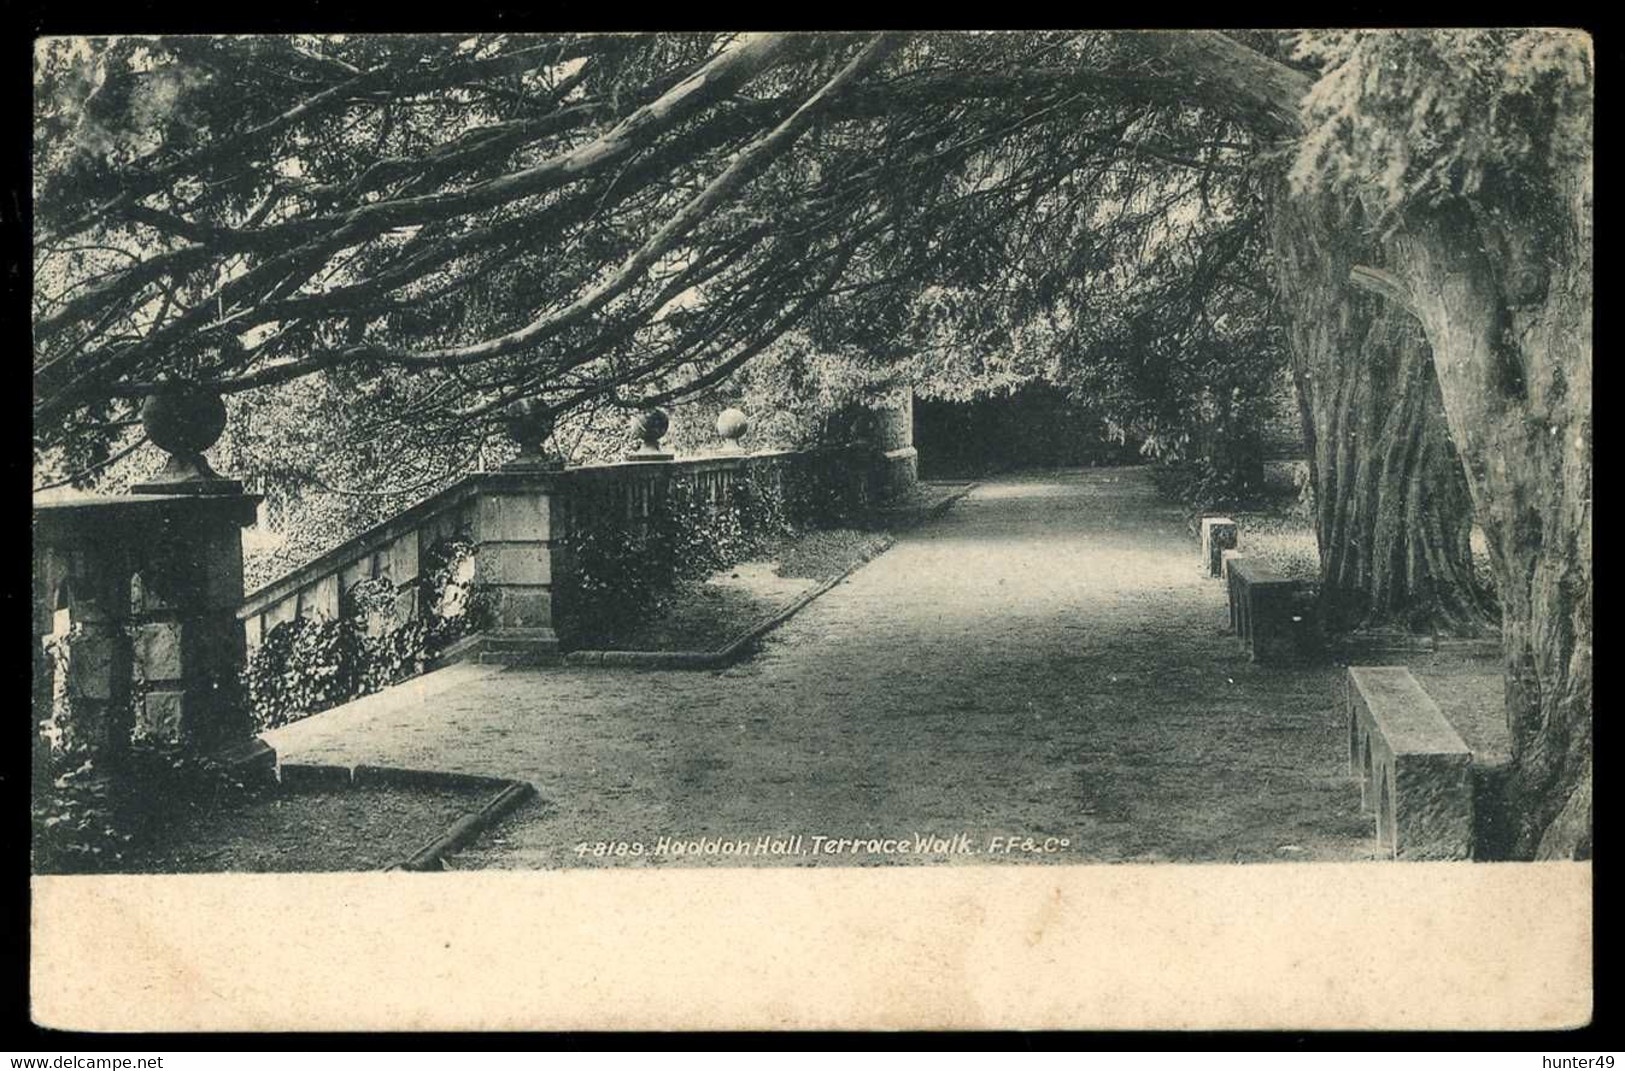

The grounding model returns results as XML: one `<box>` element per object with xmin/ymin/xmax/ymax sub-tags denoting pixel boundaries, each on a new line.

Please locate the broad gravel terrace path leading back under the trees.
<box><xmin>268</xmin><ymin>468</ymin><xmax>1373</xmax><ymax>868</ymax></box>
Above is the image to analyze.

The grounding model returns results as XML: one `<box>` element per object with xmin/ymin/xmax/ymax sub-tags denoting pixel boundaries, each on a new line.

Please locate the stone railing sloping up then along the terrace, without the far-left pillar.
<box><xmin>237</xmin><ymin>406</ymin><xmax>915</xmax><ymax>661</ymax></box>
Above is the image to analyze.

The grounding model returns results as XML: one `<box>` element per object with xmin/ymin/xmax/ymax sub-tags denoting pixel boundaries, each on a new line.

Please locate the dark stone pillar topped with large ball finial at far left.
<box><xmin>34</xmin><ymin>384</ymin><xmax>275</xmax><ymax>775</ymax></box>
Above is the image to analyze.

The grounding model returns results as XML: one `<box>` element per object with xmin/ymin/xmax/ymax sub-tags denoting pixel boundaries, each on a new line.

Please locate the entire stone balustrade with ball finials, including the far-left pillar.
<box><xmin>33</xmin><ymin>384</ymin><xmax>912</xmax><ymax>825</ymax></box>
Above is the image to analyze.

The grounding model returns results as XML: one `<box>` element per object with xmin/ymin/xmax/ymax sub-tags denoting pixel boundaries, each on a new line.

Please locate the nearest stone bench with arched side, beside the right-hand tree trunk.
<box><xmin>1349</xmin><ymin>666</ymin><xmax>1474</xmax><ymax>860</ymax></box>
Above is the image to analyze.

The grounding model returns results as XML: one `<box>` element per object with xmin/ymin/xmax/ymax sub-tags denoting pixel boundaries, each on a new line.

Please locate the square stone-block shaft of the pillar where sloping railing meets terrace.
<box><xmin>475</xmin><ymin>468</ymin><xmax>564</xmax><ymax>663</ymax></box>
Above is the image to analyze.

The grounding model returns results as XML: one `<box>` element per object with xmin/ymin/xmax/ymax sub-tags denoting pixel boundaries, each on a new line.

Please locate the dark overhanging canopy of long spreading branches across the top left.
<box><xmin>36</xmin><ymin>34</ymin><xmax>1293</xmax><ymax>481</ymax></box>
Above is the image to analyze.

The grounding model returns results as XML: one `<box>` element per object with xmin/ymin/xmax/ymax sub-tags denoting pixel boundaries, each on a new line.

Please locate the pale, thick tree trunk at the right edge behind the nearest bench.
<box><xmin>1391</xmin><ymin>161</ymin><xmax>1593</xmax><ymax>858</ymax></box>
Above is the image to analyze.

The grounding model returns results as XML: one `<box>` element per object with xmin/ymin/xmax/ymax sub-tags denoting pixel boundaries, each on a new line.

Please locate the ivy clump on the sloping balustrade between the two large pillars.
<box><xmin>244</xmin><ymin>538</ymin><xmax>489</xmax><ymax>730</ymax></box>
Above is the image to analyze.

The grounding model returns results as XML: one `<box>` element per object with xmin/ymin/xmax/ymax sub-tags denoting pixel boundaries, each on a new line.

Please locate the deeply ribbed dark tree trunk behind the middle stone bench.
<box><xmin>1271</xmin><ymin>192</ymin><xmax>1495</xmax><ymax>635</ymax></box>
